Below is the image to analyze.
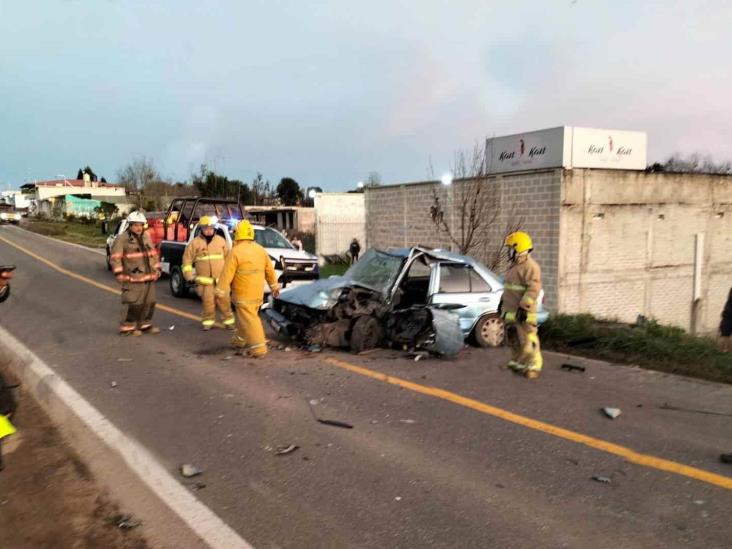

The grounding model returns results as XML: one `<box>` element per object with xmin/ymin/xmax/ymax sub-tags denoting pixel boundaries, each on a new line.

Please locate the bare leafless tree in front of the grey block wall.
<box><xmin>429</xmin><ymin>144</ymin><xmax>522</xmax><ymax>269</ymax></box>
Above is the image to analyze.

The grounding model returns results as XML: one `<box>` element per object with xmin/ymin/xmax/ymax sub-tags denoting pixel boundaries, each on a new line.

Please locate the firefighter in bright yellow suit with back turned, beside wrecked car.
<box><xmin>216</xmin><ymin>219</ymin><xmax>280</xmax><ymax>358</ymax></box>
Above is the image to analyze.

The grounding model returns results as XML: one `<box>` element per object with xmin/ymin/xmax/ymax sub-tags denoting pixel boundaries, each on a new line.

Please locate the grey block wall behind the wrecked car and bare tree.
<box><xmin>364</xmin><ymin>170</ymin><xmax>562</xmax><ymax>310</ymax></box>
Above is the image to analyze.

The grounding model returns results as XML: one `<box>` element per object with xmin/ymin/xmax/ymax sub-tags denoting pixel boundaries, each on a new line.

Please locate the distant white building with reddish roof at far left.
<box><xmin>21</xmin><ymin>174</ymin><xmax>134</xmax><ymax>216</ymax></box>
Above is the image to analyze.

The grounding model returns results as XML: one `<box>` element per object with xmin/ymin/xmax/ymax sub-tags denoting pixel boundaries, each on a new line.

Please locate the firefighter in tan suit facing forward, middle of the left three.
<box><xmin>183</xmin><ymin>215</ymin><xmax>235</xmax><ymax>330</ymax></box>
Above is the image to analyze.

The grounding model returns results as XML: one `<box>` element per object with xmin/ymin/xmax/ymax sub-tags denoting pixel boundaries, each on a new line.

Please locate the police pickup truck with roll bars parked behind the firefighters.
<box><xmin>107</xmin><ymin>198</ymin><xmax>320</xmax><ymax>297</ymax></box>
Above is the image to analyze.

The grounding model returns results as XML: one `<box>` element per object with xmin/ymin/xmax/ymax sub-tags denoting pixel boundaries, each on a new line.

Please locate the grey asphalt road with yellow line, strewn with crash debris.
<box><xmin>0</xmin><ymin>226</ymin><xmax>732</xmax><ymax>548</ymax></box>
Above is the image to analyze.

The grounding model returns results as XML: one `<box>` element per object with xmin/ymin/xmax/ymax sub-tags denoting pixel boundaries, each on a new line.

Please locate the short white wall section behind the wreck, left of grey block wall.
<box><xmin>315</xmin><ymin>193</ymin><xmax>366</xmax><ymax>257</ymax></box>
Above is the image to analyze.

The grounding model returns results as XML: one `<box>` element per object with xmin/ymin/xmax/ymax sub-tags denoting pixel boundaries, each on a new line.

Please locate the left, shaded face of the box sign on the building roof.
<box><xmin>486</xmin><ymin>127</ymin><xmax>571</xmax><ymax>173</ymax></box>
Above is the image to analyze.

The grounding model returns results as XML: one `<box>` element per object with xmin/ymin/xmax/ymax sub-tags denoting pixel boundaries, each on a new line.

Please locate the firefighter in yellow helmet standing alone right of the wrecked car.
<box><xmin>501</xmin><ymin>231</ymin><xmax>543</xmax><ymax>379</ymax></box>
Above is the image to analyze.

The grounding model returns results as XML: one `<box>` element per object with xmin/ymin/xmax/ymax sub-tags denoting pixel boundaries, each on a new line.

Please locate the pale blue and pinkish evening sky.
<box><xmin>0</xmin><ymin>0</ymin><xmax>732</xmax><ymax>191</ymax></box>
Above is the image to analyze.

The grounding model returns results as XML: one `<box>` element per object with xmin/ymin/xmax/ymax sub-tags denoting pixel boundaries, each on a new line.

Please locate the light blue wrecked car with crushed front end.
<box><xmin>263</xmin><ymin>247</ymin><xmax>547</xmax><ymax>357</ymax></box>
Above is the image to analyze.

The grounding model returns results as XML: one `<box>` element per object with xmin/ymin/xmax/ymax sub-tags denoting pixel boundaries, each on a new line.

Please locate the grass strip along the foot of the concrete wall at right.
<box><xmin>541</xmin><ymin>315</ymin><xmax>732</xmax><ymax>383</ymax></box>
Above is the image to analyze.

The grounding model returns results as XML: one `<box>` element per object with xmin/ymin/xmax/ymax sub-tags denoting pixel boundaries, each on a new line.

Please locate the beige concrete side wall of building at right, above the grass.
<box><xmin>558</xmin><ymin>170</ymin><xmax>732</xmax><ymax>332</ymax></box>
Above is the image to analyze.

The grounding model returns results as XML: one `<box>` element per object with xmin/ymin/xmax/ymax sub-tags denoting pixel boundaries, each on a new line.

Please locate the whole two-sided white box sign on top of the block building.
<box><xmin>486</xmin><ymin>126</ymin><xmax>646</xmax><ymax>173</ymax></box>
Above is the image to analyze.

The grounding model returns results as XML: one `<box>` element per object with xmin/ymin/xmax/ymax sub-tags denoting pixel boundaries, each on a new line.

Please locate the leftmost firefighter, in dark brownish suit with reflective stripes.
<box><xmin>109</xmin><ymin>212</ymin><xmax>160</xmax><ymax>336</ymax></box>
